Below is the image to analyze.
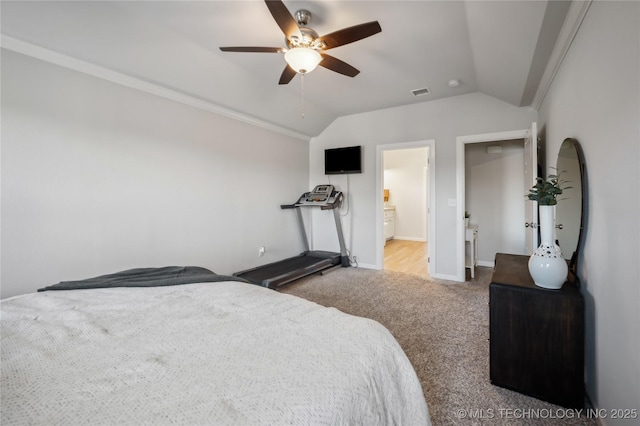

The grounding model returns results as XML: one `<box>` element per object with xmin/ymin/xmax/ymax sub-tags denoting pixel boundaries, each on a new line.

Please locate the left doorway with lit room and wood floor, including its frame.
<box><xmin>376</xmin><ymin>140</ymin><xmax>435</xmax><ymax>276</ymax></box>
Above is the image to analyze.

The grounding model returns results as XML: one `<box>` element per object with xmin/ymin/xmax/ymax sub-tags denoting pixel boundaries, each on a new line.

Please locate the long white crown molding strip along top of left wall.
<box><xmin>0</xmin><ymin>34</ymin><xmax>311</xmax><ymax>142</ymax></box>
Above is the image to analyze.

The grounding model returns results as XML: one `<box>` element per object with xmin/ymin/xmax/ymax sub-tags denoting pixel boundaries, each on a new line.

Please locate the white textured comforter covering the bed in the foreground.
<box><xmin>0</xmin><ymin>282</ymin><xmax>430</xmax><ymax>426</ymax></box>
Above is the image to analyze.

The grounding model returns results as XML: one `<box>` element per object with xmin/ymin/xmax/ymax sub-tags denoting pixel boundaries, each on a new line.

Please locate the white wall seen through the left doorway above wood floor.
<box><xmin>384</xmin><ymin>148</ymin><xmax>429</xmax><ymax>241</ymax></box>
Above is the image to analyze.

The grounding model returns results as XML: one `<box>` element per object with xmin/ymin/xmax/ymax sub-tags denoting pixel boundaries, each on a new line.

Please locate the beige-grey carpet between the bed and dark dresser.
<box><xmin>279</xmin><ymin>268</ymin><xmax>598</xmax><ymax>425</ymax></box>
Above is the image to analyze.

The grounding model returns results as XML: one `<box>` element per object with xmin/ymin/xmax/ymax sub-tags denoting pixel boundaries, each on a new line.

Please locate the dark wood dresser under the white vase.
<box><xmin>489</xmin><ymin>253</ymin><xmax>584</xmax><ymax>408</ymax></box>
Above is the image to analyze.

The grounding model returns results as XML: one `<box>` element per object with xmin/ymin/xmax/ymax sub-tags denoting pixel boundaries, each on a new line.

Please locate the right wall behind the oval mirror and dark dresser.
<box><xmin>539</xmin><ymin>1</ymin><xmax>640</xmax><ymax>425</ymax></box>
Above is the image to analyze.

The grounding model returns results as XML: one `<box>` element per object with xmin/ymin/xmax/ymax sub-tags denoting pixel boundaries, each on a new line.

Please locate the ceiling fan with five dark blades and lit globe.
<box><xmin>220</xmin><ymin>0</ymin><xmax>382</xmax><ymax>84</ymax></box>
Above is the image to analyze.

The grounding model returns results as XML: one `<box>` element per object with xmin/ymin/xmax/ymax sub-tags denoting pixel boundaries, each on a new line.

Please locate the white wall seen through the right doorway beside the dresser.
<box><xmin>465</xmin><ymin>140</ymin><xmax>528</xmax><ymax>266</ymax></box>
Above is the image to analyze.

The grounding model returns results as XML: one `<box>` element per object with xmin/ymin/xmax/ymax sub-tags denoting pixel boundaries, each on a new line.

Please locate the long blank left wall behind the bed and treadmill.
<box><xmin>1</xmin><ymin>50</ymin><xmax>309</xmax><ymax>297</ymax></box>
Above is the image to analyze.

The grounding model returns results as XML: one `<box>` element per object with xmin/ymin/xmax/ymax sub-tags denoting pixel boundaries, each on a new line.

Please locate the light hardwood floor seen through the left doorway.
<box><xmin>384</xmin><ymin>240</ymin><xmax>429</xmax><ymax>276</ymax></box>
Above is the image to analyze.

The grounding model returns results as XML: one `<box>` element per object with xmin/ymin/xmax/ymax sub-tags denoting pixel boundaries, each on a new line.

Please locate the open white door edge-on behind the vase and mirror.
<box><xmin>524</xmin><ymin>123</ymin><xmax>539</xmax><ymax>254</ymax></box>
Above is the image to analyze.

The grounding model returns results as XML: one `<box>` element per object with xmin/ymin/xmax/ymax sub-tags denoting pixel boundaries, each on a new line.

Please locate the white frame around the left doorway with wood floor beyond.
<box><xmin>375</xmin><ymin>139</ymin><xmax>437</xmax><ymax>277</ymax></box>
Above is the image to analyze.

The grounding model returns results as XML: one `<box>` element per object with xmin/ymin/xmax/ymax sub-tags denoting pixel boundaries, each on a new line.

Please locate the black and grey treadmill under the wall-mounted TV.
<box><xmin>233</xmin><ymin>185</ymin><xmax>351</xmax><ymax>289</ymax></box>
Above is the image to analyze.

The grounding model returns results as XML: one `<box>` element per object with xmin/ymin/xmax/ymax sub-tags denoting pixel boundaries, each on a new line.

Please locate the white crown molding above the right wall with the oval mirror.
<box><xmin>531</xmin><ymin>0</ymin><xmax>592</xmax><ymax>111</ymax></box>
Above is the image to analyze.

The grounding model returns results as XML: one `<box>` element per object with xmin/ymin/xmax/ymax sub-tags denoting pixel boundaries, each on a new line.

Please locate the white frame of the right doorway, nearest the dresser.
<box><xmin>456</xmin><ymin>129</ymin><xmax>531</xmax><ymax>282</ymax></box>
